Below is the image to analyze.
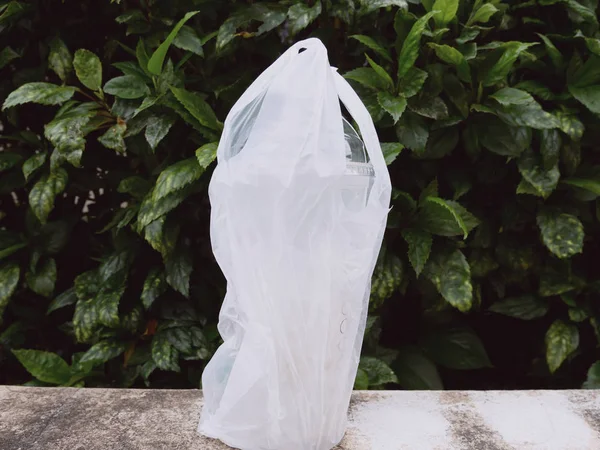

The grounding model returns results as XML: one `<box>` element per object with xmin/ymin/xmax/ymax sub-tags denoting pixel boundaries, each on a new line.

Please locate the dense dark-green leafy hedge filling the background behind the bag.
<box><xmin>0</xmin><ymin>0</ymin><xmax>600</xmax><ymax>389</ymax></box>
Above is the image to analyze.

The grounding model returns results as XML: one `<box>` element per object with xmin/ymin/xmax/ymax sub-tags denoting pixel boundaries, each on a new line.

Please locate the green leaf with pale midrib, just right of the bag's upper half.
<box><xmin>419</xmin><ymin>197</ymin><xmax>479</xmax><ymax>239</ymax></box>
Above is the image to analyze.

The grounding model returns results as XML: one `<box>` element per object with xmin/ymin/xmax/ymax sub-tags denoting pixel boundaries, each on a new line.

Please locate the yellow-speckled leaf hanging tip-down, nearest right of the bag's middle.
<box><xmin>423</xmin><ymin>250</ymin><xmax>473</xmax><ymax>312</ymax></box>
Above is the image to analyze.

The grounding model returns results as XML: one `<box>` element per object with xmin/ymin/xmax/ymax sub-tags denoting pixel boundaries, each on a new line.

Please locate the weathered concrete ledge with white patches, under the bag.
<box><xmin>0</xmin><ymin>386</ymin><xmax>600</xmax><ymax>450</ymax></box>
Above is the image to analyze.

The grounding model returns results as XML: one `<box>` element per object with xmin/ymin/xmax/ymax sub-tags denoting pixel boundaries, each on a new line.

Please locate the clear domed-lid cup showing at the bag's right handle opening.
<box><xmin>342</xmin><ymin>118</ymin><xmax>375</xmax><ymax>210</ymax></box>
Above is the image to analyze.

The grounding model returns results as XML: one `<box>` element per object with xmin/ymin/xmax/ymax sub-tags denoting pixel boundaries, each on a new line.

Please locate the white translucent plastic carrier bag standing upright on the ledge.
<box><xmin>198</xmin><ymin>39</ymin><xmax>391</xmax><ymax>450</ymax></box>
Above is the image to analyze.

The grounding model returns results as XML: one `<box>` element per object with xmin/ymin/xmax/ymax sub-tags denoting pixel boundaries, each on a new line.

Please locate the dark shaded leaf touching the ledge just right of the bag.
<box><xmin>392</xmin><ymin>347</ymin><xmax>444</xmax><ymax>391</ymax></box>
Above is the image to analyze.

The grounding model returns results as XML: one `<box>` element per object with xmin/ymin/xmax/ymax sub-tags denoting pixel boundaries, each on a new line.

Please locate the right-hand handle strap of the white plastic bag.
<box><xmin>331</xmin><ymin>71</ymin><xmax>391</xmax><ymax>205</ymax></box>
